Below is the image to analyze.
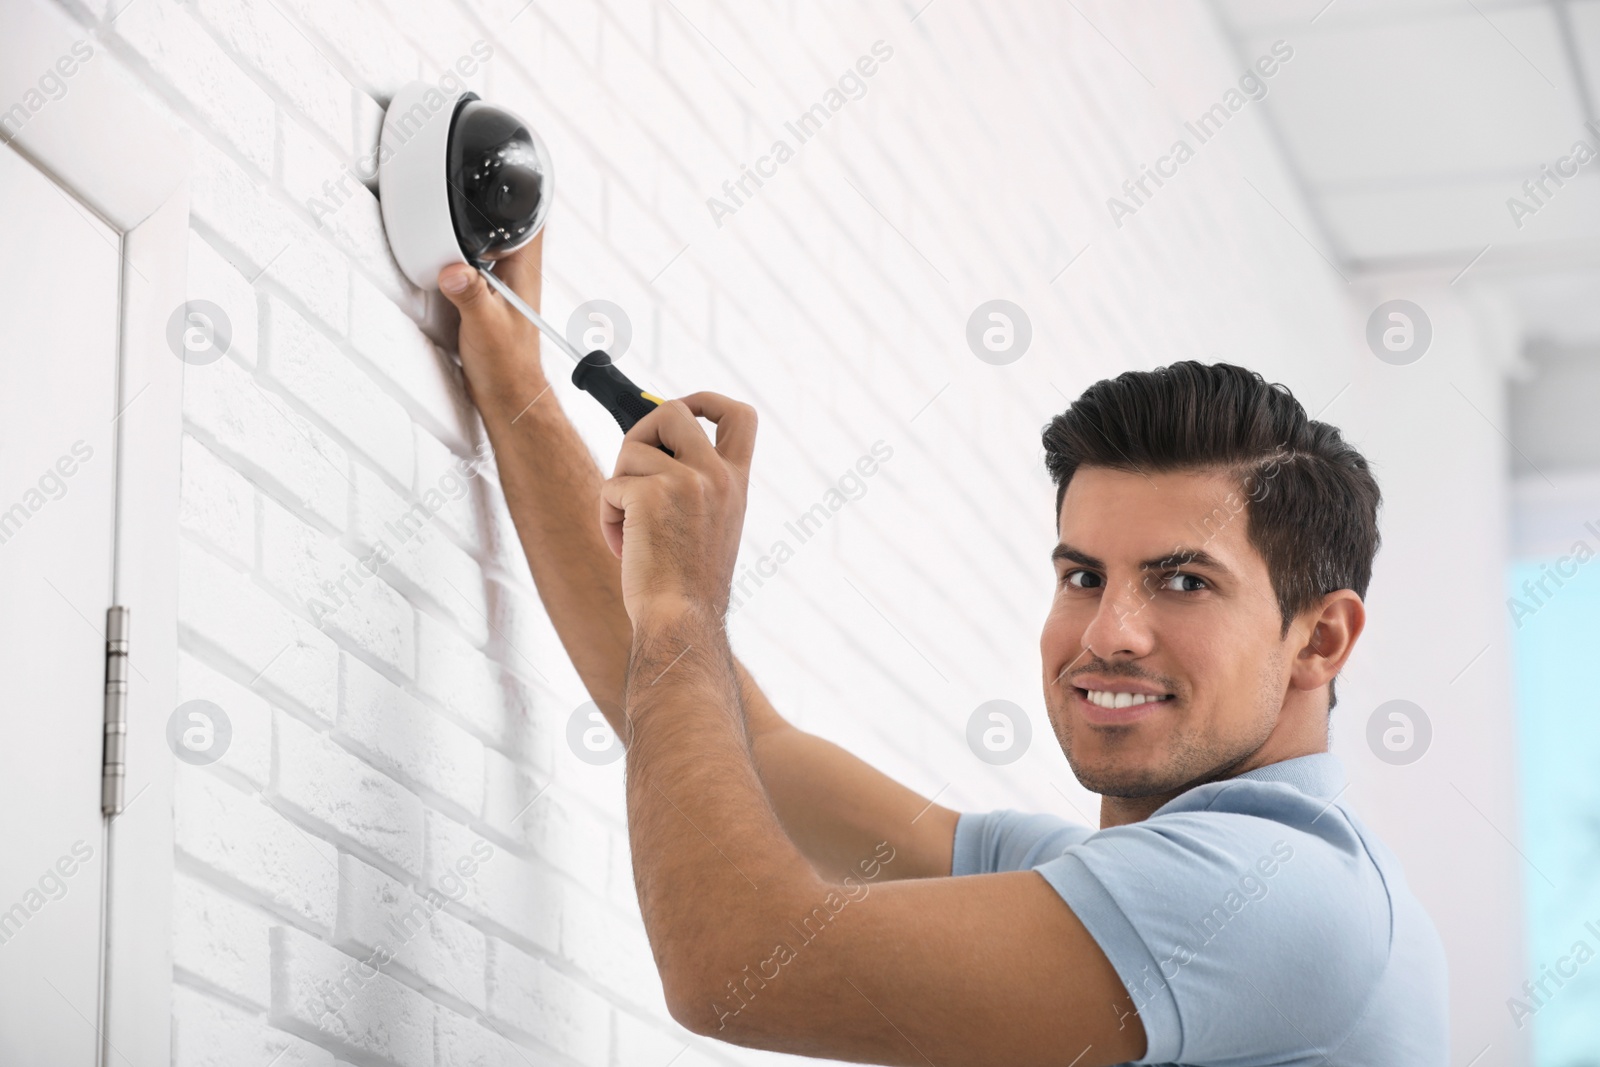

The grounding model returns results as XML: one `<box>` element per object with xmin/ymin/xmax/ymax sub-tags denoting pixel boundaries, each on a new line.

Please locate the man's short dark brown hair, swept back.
<box><xmin>1045</xmin><ymin>360</ymin><xmax>1382</xmax><ymax>712</ymax></box>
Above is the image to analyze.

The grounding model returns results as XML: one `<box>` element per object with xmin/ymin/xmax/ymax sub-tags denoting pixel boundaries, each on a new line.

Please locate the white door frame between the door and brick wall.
<box><xmin>0</xmin><ymin>0</ymin><xmax>189</xmax><ymax>1064</ymax></box>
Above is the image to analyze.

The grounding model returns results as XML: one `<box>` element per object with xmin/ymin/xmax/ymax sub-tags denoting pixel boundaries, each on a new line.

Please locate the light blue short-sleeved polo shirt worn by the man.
<box><xmin>950</xmin><ymin>752</ymin><xmax>1450</xmax><ymax>1067</ymax></box>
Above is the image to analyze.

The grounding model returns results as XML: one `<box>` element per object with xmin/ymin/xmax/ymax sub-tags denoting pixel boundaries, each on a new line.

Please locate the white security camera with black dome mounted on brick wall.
<box><xmin>378</xmin><ymin>82</ymin><xmax>555</xmax><ymax>290</ymax></box>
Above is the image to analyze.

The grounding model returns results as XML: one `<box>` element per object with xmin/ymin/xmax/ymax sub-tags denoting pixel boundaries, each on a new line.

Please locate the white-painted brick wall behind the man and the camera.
<box><xmin>81</xmin><ymin>0</ymin><xmax>1349</xmax><ymax>1067</ymax></box>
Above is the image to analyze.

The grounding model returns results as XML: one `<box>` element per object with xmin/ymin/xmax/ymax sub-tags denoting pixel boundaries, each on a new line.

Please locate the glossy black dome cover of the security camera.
<box><xmin>445</xmin><ymin>96</ymin><xmax>552</xmax><ymax>262</ymax></box>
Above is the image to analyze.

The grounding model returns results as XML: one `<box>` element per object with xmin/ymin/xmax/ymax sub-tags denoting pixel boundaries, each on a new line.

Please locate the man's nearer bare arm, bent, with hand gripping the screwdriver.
<box><xmin>576</xmin><ymin>392</ymin><xmax>1146</xmax><ymax>1067</ymax></box>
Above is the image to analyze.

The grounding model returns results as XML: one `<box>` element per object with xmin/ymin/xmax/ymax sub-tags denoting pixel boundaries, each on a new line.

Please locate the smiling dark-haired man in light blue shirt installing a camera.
<box><xmin>440</xmin><ymin>242</ymin><xmax>1446</xmax><ymax>1067</ymax></box>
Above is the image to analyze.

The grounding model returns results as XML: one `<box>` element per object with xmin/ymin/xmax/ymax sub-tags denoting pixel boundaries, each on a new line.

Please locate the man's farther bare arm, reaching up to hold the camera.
<box><xmin>440</xmin><ymin>234</ymin><xmax>957</xmax><ymax>878</ymax></box>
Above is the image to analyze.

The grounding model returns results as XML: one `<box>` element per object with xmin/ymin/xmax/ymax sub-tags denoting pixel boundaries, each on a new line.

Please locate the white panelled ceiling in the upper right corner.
<box><xmin>1211</xmin><ymin>0</ymin><xmax>1600</xmax><ymax>477</ymax></box>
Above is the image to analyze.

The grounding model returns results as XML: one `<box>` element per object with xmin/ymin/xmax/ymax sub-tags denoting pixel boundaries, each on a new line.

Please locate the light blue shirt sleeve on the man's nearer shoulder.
<box><xmin>1036</xmin><ymin>811</ymin><xmax>1392</xmax><ymax>1067</ymax></box>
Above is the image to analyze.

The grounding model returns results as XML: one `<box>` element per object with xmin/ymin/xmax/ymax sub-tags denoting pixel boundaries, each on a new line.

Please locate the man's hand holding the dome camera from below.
<box><xmin>438</xmin><ymin>230</ymin><xmax>549</xmax><ymax>419</ymax></box>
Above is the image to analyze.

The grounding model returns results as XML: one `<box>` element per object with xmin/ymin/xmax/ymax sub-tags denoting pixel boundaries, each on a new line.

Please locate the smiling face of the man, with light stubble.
<box><xmin>1040</xmin><ymin>467</ymin><xmax>1294</xmax><ymax>797</ymax></box>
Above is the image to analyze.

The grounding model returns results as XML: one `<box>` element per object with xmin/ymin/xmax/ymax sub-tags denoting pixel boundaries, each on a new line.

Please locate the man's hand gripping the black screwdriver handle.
<box><xmin>600</xmin><ymin>392</ymin><xmax>755</xmax><ymax>629</ymax></box>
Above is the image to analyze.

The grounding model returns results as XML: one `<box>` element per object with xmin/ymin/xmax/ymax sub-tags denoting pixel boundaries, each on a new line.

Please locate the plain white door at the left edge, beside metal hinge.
<box><xmin>0</xmin><ymin>139</ymin><xmax>123</xmax><ymax>1067</ymax></box>
